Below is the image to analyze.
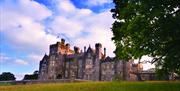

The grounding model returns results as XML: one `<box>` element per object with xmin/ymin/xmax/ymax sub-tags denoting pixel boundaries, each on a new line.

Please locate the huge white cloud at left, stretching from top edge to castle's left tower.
<box><xmin>0</xmin><ymin>0</ymin><xmax>56</xmax><ymax>53</ymax></box>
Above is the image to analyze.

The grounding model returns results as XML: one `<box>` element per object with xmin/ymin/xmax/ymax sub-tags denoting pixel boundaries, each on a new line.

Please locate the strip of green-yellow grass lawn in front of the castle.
<box><xmin>0</xmin><ymin>81</ymin><xmax>180</xmax><ymax>91</ymax></box>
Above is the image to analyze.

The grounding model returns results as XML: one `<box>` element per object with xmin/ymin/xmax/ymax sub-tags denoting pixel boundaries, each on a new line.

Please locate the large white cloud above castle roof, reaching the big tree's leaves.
<box><xmin>46</xmin><ymin>0</ymin><xmax>115</xmax><ymax>56</ymax></box>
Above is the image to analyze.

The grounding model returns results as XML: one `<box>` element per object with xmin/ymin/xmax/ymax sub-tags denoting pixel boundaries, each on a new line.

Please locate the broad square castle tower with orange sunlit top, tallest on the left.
<box><xmin>47</xmin><ymin>39</ymin><xmax>69</xmax><ymax>79</ymax></box>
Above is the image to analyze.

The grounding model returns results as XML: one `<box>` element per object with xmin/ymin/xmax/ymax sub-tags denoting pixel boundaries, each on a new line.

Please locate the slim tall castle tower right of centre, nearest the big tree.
<box><xmin>93</xmin><ymin>43</ymin><xmax>102</xmax><ymax>81</ymax></box>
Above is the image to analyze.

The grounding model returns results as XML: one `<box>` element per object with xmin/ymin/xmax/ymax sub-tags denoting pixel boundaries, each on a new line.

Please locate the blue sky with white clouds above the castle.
<box><xmin>0</xmin><ymin>0</ymin><xmax>154</xmax><ymax>80</ymax></box>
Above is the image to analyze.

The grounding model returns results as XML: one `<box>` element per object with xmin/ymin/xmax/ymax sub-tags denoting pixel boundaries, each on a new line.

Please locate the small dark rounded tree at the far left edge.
<box><xmin>0</xmin><ymin>72</ymin><xmax>16</xmax><ymax>81</ymax></box>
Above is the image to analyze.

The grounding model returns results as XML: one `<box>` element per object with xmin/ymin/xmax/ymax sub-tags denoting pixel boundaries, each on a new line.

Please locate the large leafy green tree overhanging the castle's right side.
<box><xmin>111</xmin><ymin>0</ymin><xmax>180</xmax><ymax>79</ymax></box>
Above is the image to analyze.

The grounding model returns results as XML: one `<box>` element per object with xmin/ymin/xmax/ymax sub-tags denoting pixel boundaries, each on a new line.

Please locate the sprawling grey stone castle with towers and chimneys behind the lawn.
<box><xmin>39</xmin><ymin>39</ymin><xmax>142</xmax><ymax>81</ymax></box>
